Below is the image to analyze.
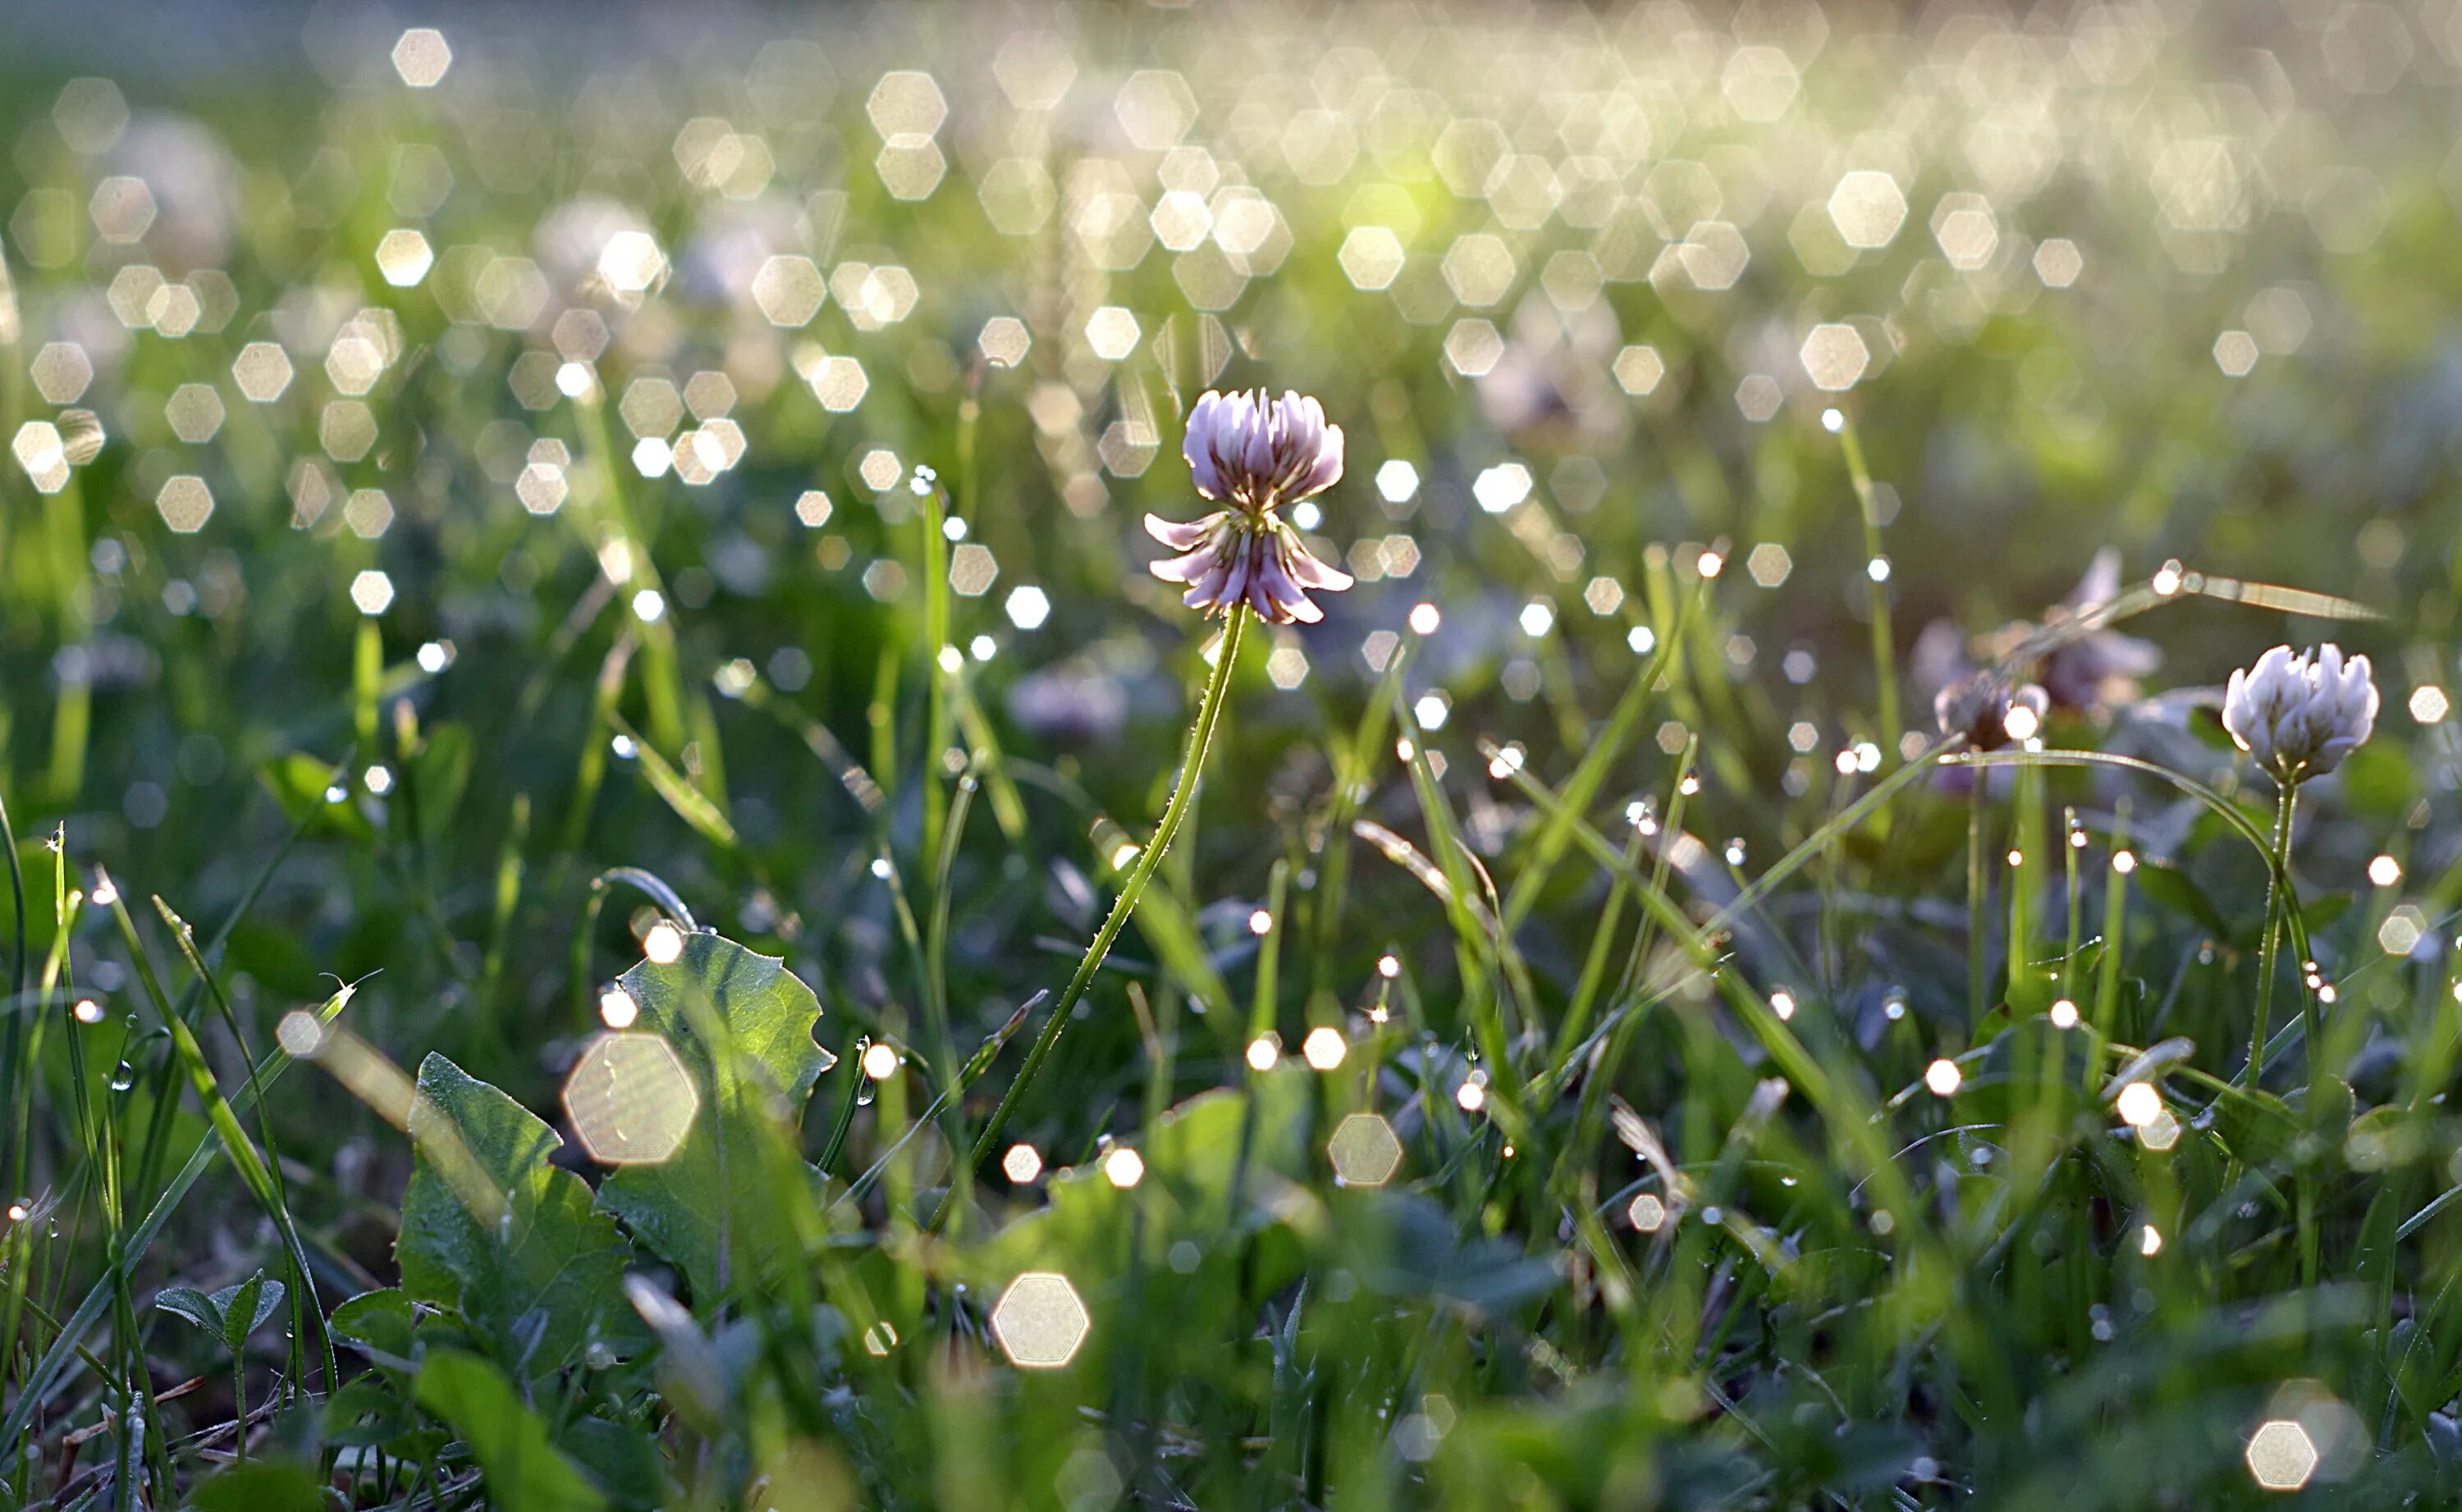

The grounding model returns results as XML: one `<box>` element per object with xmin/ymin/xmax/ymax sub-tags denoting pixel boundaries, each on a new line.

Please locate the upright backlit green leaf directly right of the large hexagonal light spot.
<box><xmin>598</xmin><ymin>934</ymin><xmax>837</xmax><ymax>1303</ymax></box>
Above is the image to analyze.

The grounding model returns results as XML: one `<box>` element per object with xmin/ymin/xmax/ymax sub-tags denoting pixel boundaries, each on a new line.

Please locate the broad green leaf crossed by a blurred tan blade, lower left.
<box><xmin>394</xmin><ymin>1054</ymin><xmax>640</xmax><ymax>1374</ymax></box>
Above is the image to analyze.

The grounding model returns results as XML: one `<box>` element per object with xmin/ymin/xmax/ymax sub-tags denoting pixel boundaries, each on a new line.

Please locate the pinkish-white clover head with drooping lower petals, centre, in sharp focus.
<box><xmin>1145</xmin><ymin>389</ymin><xmax>1352</xmax><ymax>625</ymax></box>
